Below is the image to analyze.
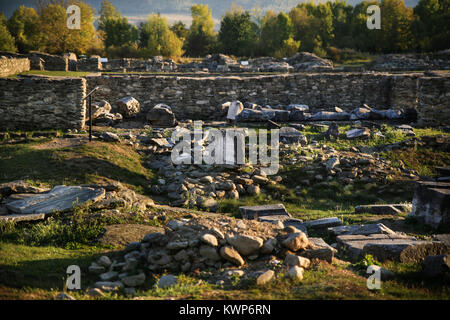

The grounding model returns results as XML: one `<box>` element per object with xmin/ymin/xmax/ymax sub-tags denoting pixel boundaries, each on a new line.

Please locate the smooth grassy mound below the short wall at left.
<box><xmin>0</xmin><ymin>139</ymin><xmax>153</xmax><ymax>192</ymax></box>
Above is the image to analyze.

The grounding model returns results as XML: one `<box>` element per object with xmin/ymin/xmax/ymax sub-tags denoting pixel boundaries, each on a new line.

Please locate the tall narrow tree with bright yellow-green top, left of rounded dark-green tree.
<box><xmin>186</xmin><ymin>4</ymin><xmax>217</xmax><ymax>56</ymax></box>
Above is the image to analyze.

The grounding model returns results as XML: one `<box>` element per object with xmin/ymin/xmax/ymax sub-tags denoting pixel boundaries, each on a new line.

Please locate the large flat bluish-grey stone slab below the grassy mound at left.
<box><xmin>6</xmin><ymin>186</ymin><xmax>105</xmax><ymax>214</ymax></box>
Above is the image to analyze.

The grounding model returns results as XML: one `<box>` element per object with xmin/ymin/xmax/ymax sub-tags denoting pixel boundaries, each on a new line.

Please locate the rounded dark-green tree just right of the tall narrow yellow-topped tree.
<box><xmin>219</xmin><ymin>6</ymin><xmax>258</xmax><ymax>56</ymax></box>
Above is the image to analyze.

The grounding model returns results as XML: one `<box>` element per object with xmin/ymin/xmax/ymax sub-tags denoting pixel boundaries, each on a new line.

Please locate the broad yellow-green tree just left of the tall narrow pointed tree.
<box><xmin>140</xmin><ymin>14</ymin><xmax>183</xmax><ymax>57</ymax></box>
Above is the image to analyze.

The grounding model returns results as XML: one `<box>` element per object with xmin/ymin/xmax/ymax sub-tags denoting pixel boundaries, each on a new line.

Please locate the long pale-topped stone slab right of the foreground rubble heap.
<box><xmin>336</xmin><ymin>234</ymin><xmax>431</xmax><ymax>261</ymax></box>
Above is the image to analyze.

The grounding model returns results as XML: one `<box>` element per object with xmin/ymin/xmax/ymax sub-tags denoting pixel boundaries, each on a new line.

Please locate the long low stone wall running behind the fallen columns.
<box><xmin>86</xmin><ymin>73</ymin><xmax>421</xmax><ymax>120</ymax></box>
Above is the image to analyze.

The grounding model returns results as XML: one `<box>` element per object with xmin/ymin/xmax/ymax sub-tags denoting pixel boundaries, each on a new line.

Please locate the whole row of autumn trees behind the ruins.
<box><xmin>0</xmin><ymin>0</ymin><xmax>450</xmax><ymax>58</ymax></box>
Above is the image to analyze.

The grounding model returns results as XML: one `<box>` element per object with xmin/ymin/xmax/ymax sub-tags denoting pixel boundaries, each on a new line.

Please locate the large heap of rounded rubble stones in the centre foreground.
<box><xmin>89</xmin><ymin>215</ymin><xmax>335</xmax><ymax>291</ymax></box>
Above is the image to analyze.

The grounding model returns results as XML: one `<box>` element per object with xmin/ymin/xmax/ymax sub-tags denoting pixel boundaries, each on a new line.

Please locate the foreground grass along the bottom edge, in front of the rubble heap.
<box><xmin>0</xmin><ymin>243</ymin><xmax>449</xmax><ymax>300</ymax></box>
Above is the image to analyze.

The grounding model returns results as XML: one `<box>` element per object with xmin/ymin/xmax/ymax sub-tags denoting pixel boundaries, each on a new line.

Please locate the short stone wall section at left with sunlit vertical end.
<box><xmin>0</xmin><ymin>77</ymin><xmax>86</xmax><ymax>131</ymax></box>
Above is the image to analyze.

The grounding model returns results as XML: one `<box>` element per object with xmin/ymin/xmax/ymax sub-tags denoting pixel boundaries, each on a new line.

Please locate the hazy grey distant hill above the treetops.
<box><xmin>0</xmin><ymin>0</ymin><xmax>418</xmax><ymax>19</ymax></box>
